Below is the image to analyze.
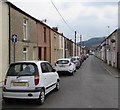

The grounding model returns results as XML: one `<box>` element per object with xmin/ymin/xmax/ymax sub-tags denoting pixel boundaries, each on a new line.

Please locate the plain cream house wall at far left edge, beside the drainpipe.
<box><xmin>0</xmin><ymin>2</ymin><xmax>9</xmax><ymax>85</ymax></box>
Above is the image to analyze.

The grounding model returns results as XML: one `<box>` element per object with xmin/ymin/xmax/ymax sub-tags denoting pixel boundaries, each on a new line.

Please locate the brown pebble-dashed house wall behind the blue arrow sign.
<box><xmin>10</xmin><ymin>7</ymin><xmax>38</xmax><ymax>62</ymax></box>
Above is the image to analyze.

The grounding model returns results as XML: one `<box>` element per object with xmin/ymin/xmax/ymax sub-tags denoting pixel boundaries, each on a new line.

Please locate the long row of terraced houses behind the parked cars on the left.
<box><xmin>0</xmin><ymin>2</ymin><xmax>85</xmax><ymax>86</ymax></box>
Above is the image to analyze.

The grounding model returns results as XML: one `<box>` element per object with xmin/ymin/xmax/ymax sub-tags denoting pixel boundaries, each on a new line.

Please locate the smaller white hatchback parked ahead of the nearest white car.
<box><xmin>55</xmin><ymin>58</ymin><xmax>76</xmax><ymax>75</ymax></box>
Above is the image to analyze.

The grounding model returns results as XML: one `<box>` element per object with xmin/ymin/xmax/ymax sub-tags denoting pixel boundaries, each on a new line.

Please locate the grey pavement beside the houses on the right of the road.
<box><xmin>97</xmin><ymin>57</ymin><xmax>120</xmax><ymax>78</ymax></box>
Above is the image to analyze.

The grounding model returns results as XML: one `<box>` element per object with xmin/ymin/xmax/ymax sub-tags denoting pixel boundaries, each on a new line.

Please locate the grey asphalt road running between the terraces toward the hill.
<box><xmin>2</xmin><ymin>56</ymin><xmax>118</xmax><ymax>109</ymax></box>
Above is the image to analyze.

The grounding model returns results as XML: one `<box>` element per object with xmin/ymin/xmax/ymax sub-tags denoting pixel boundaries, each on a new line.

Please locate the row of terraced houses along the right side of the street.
<box><xmin>95</xmin><ymin>28</ymin><xmax>120</xmax><ymax>69</ymax></box>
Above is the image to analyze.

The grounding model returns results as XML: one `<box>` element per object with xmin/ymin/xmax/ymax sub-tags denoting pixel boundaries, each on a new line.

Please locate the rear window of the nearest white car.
<box><xmin>7</xmin><ymin>63</ymin><xmax>38</xmax><ymax>76</ymax></box>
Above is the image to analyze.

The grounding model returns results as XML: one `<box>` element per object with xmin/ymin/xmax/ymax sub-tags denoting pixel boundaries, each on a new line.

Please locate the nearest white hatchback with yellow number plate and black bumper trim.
<box><xmin>3</xmin><ymin>61</ymin><xmax>60</xmax><ymax>104</ymax></box>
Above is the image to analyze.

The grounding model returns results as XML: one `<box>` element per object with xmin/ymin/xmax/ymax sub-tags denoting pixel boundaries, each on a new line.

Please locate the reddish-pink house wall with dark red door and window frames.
<box><xmin>37</xmin><ymin>22</ymin><xmax>51</xmax><ymax>62</ymax></box>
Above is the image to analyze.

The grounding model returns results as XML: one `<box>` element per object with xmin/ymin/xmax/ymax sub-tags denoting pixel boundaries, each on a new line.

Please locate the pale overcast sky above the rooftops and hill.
<box><xmin>9</xmin><ymin>0</ymin><xmax>119</xmax><ymax>41</ymax></box>
